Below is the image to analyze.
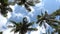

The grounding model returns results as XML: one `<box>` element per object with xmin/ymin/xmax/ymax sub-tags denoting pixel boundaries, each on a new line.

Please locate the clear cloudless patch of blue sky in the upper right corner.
<box><xmin>44</xmin><ymin>0</ymin><xmax>60</xmax><ymax>13</ymax></box>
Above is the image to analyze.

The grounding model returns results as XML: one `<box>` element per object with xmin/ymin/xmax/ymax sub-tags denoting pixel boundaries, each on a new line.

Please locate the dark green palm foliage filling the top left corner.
<box><xmin>0</xmin><ymin>0</ymin><xmax>12</xmax><ymax>17</ymax></box>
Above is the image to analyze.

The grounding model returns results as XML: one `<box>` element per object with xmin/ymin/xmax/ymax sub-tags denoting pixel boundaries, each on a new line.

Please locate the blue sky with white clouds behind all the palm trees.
<box><xmin>0</xmin><ymin>0</ymin><xmax>60</xmax><ymax>34</ymax></box>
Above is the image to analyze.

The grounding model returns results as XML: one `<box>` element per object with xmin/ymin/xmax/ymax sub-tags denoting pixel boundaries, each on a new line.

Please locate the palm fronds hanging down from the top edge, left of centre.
<box><xmin>15</xmin><ymin>0</ymin><xmax>40</xmax><ymax>11</ymax></box>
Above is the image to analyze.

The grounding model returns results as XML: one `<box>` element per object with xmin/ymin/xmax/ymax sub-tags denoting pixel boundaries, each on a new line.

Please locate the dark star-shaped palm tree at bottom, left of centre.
<box><xmin>9</xmin><ymin>17</ymin><xmax>37</xmax><ymax>34</ymax></box>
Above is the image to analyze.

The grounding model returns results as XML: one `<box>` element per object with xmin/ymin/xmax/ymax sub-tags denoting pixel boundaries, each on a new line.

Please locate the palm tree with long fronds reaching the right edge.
<box><xmin>37</xmin><ymin>10</ymin><xmax>60</xmax><ymax>32</ymax></box>
